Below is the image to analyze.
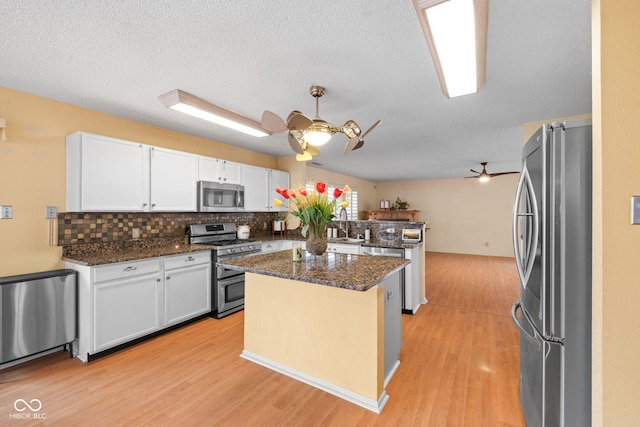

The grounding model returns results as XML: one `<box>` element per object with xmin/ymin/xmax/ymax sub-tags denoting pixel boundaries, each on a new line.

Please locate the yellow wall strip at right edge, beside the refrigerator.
<box><xmin>592</xmin><ymin>0</ymin><xmax>640</xmax><ymax>427</ymax></box>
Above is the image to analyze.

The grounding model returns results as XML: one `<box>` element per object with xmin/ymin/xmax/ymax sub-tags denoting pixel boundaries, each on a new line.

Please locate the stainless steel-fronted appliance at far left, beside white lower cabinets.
<box><xmin>0</xmin><ymin>269</ymin><xmax>77</xmax><ymax>364</ymax></box>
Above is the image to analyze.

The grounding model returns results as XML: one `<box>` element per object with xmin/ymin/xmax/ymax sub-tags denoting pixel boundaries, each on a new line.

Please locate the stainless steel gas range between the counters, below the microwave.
<box><xmin>187</xmin><ymin>223</ymin><xmax>262</xmax><ymax>319</ymax></box>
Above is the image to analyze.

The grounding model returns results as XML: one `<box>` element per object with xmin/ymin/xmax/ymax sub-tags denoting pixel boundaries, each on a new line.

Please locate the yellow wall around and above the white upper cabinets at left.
<box><xmin>0</xmin><ymin>87</ymin><xmax>277</xmax><ymax>276</ymax></box>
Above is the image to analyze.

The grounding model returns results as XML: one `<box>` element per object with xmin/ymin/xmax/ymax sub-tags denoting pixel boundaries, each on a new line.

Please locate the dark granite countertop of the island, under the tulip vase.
<box><xmin>217</xmin><ymin>250</ymin><xmax>411</xmax><ymax>291</ymax></box>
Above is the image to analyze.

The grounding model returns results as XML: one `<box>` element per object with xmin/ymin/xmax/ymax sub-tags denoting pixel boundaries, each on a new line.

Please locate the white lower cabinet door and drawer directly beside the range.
<box><xmin>164</xmin><ymin>252</ymin><xmax>211</xmax><ymax>326</ymax></box>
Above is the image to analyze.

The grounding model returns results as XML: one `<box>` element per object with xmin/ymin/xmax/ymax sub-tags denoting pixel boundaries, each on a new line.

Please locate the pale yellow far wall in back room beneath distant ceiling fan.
<box><xmin>377</xmin><ymin>175</ymin><xmax>520</xmax><ymax>257</ymax></box>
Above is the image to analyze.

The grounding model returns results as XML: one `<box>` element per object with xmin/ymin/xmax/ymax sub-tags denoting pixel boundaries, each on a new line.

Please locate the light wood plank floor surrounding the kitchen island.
<box><xmin>0</xmin><ymin>253</ymin><xmax>524</xmax><ymax>426</ymax></box>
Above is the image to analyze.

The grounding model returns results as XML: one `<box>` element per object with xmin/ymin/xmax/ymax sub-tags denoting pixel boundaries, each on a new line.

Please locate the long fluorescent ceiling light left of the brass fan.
<box><xmin>158</xmin><ymin>89</ymin><xmax>271</xmax><ymax>136</ymax></box>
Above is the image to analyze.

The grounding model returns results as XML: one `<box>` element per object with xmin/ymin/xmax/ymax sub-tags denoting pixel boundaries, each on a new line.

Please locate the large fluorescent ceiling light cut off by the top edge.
<box><xmin>413</xmin><ymin>0</ymin><xmax>489</xmax><ymax>98</ymax></box>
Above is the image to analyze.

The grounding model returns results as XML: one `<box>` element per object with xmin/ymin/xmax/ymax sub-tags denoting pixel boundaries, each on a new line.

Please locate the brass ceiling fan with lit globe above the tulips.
<box><xmin>261</xmin><ymin>86</ymin><xmax>380</xmax><ymax>161</ymax></box>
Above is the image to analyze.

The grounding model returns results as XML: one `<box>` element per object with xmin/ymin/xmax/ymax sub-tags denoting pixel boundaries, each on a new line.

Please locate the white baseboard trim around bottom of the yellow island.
<box><xmin>240</xmin><ymin>350</ymin><xmax>388</xmax><ymax>414</ymax></box>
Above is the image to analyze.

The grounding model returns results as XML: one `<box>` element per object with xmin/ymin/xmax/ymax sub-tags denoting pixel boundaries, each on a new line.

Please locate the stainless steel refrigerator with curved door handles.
<box><xmin>511</xmin><ymin>119</ymin><xmax>592</xmax><ymax>427</ymax></box>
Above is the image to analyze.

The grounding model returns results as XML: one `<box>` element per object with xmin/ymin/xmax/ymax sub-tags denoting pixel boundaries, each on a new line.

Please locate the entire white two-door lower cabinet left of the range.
<box><xmin>67</xmin><ymin>251</ymin><xmax>211</xmax><ymax>362</ymax></box>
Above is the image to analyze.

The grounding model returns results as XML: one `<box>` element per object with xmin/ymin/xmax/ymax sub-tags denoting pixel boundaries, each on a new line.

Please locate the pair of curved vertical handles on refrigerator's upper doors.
<box><xmin>512</xmin><ymin>165</ymin><xmax>539</xmax><ymax>286</ymax></box>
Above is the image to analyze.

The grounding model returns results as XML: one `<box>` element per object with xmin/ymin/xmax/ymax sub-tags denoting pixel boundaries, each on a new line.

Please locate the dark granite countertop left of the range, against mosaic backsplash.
<box><xmin>62</xmin><ymin>238</ymin><xmax>211</xmax><ymax>266</ymax></box>
